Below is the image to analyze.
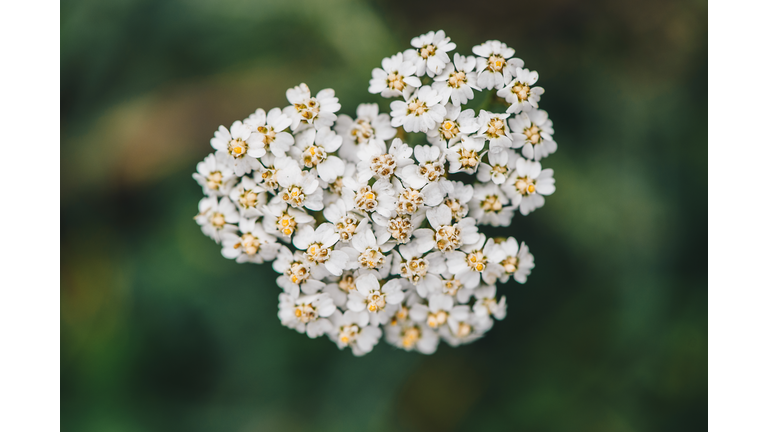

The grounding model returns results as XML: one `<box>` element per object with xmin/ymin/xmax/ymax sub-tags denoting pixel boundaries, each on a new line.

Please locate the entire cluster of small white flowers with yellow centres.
<box><xmin>193</xmin><ymin>31</ymin><xmax>557</xmax><ymax>355</ymax></box>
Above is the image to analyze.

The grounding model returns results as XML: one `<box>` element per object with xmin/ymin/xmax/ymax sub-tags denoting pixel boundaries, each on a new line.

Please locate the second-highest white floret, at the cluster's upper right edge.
<box><xmin>472</xmin><ymin>40</ymin><xmax>523</xmax><ymax>89</ymax></box>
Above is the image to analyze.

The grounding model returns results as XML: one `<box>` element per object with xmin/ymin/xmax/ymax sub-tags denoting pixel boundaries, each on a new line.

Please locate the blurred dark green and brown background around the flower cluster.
<box><xmin>61</xmin><ymin>0</ymin><xmax>707</xmax><ymax>432</ymax></box>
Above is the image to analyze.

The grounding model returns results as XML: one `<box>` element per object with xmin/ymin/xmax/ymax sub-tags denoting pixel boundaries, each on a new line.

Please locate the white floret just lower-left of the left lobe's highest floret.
<box><xmin>243</xmin><ymin>108</ymin><xmax>293</xmax><ymax>157</ymax></box>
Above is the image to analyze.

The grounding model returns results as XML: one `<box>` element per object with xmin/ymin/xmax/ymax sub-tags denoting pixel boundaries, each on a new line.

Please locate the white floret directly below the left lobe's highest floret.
<box><xmin>291</xmin><ymin>127</ymin><xmax>346</xmax><ymax>182</ymax></box>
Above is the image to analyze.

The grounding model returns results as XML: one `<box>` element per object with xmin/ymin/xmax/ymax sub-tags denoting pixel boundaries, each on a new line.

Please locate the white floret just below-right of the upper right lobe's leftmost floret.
<box><xmin>389</xmin><ymin>85</ymin><xmax>445</xmax><ymax>132</ymax></box>
